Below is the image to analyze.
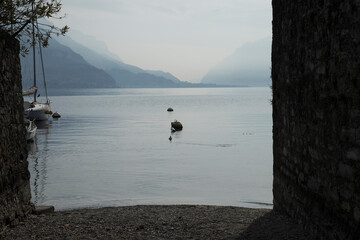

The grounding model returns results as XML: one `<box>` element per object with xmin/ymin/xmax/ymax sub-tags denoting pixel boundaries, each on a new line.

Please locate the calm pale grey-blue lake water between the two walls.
<box><xmin>28</xmin><ymin>88</ymin><xmax>273</xmax><ymax>210</ymax></box>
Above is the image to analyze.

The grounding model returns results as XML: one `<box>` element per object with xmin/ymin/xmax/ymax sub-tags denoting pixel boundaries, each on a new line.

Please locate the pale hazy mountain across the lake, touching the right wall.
<box><xmin>201</xmin><ymin>37</ymin><xmax>272</xmax><ymax>86</ymax></box>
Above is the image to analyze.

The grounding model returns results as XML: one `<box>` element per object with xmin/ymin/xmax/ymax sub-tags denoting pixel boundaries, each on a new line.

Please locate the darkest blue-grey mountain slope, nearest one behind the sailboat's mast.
<box><xmin>21</xmin><ymin>39</ymin><xmax>116</xmax><ymax>89</ymax></box>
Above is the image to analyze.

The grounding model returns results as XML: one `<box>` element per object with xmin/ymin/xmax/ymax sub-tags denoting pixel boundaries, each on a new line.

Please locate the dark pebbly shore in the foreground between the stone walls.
<box><xmin>3</xmin><ymin>205</ymin><xmax>311</xmax><ymax>240</ymax></box>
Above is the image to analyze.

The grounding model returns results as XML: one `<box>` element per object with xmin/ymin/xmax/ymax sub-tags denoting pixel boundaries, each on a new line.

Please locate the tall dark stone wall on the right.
<box><xmin>272</xmin><ymin>0</ymin><xmax>360</xmax><ymax>239</ymax></box>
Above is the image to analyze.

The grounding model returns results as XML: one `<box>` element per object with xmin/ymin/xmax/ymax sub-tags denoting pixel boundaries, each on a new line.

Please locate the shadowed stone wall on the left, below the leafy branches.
<box><xmin>0</xmin><ymin>30</ymin><xmax>33</xmax><ymax>234</ymax></box>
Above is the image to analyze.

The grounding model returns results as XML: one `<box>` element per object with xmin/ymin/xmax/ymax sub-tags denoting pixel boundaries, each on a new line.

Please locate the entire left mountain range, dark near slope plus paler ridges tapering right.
<box><xmin>21</xmin><ymin>29</ymin><xmax>216</xmax><ymax>90</ymax></box>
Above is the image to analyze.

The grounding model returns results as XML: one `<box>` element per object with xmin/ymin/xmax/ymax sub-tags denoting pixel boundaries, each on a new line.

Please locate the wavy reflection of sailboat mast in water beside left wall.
<box><xmin>27</xmin><ymin>121</ymin><xmax>51</xmax><ymax>205</ymax></box>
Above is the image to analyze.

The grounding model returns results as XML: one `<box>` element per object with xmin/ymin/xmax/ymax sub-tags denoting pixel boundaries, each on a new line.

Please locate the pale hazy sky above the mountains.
<box><xmin>56</xmin><ymin>0</ymin><xmax>272</xmax><ymax>82</ymax></box>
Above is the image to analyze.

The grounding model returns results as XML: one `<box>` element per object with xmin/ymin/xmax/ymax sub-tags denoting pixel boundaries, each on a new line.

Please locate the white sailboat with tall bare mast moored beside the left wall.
<box><xmin>23</xmin><ymin>12</ymin><xmax>52</xmax><ymax>121</ymax></box>
